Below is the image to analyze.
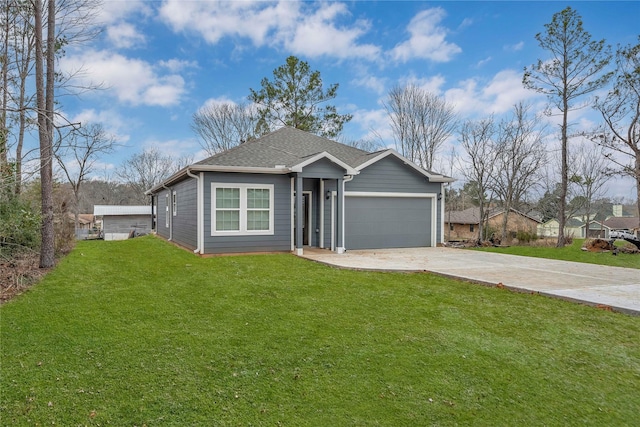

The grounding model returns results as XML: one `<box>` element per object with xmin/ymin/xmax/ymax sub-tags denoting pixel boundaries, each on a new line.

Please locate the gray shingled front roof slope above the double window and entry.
<box><xmin>196</xmin><ymin>127</ymin><xmax>376</xmax><ymax>168</ymax></box>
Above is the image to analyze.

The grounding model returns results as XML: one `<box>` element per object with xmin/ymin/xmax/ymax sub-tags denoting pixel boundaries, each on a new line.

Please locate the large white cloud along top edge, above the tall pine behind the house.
<box><xmin>160</xmin><ymin>0</ymin><xmax>380</xmax><ymax>60</ymax></box>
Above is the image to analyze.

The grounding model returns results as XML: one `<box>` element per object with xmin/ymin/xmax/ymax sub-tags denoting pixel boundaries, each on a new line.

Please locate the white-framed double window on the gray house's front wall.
<box><xmin>211</xmin><ymin>183</ymin><xmax>273</xmax><ymax>236</ymax></box>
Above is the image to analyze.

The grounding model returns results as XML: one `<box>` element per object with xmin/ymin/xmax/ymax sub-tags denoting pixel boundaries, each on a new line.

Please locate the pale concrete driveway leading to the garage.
<box><xmin>303</xmin><ymin>248</ymin><xmax>640</xmax><ymax>315</ymax></box>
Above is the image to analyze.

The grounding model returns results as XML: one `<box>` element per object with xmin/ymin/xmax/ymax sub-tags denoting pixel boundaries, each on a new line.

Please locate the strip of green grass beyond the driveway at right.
<box><xmin>474</xmin><ymin>239</ymin><xmax>640</xmax><ymax>268</ymax></box>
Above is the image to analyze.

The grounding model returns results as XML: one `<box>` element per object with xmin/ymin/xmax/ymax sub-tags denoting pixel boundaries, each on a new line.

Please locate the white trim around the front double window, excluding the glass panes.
<box><xmin>211</xmin><ymin>182</ymin><xmax>275</xmax><ymax>236</ymax></box>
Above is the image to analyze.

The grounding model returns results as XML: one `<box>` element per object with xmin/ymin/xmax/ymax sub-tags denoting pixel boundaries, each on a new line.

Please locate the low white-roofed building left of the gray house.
<box><xmin>93</xmin><ymin>205</ymin><xmax>153</xmax><ymax>240</ymax></box>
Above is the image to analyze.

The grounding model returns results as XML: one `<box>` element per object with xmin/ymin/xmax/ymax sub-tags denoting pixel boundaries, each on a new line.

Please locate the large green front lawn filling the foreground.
<box><xmin>0</xmin><ymin>236</ymin><xmax>640</xmax><ymax>426</ymax></box>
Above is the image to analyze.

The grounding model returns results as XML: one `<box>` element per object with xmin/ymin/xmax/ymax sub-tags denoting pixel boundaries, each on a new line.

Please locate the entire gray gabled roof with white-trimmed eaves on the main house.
<box><xmin>147</xmin><ymin>127</ymin><xmax>454</xmax><ymax>194</ymax></box>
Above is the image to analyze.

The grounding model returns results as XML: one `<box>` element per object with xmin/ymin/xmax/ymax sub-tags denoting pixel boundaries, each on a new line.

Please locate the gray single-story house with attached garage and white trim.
<box><xmin>147</xmin><ymin>127</ymin><xmax>453</xmax><ymax>254</ymax></box>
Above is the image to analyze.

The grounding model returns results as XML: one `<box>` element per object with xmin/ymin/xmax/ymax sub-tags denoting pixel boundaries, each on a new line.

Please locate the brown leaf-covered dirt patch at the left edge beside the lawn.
<box><xmin>0</xmin><ymin>252</ymin><xmax>49</xmax><ymax>304</ymax></box>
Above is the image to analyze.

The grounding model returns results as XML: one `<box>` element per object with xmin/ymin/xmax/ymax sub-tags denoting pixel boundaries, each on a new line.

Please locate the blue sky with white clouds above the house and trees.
<box><xmin>53</xmin><ymin>0</ymin><xmax>640</xmax><ymax>198</ymax></box>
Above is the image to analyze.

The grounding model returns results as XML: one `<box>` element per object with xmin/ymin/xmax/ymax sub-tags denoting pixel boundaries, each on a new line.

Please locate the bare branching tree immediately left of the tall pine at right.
<box><xmin>494</xmin><ymin>103</ymin><xmax>546</xmax><ymax>241</ymax></box>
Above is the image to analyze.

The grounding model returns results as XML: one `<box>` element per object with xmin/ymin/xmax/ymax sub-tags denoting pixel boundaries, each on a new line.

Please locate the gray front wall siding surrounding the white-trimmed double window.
<box><xmin>204</xmin><ymin>172</ymin><xmax>292</xmax><ymax>254</ymax></box>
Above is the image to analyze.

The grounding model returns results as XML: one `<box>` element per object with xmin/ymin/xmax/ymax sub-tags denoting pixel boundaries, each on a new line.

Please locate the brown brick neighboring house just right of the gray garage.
<box><xmin>444</xmin><ymin>207</ymin><xmax>540</xmax><ymax>240</ymax></box>
